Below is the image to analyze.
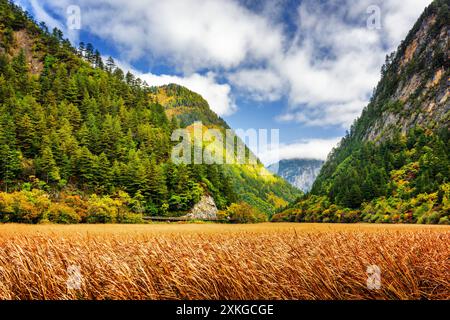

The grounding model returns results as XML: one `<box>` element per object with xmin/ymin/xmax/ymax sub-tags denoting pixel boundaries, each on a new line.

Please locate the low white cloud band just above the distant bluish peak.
<box><xmin>258</xmin><ymin>137</ymin><xmax>341</xmax><ymax>166</ymax></box>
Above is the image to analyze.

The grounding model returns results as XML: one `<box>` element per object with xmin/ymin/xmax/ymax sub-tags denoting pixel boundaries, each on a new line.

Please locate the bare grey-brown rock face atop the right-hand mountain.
<box><xmin>356</xmin><ymin>1</ymin><xmax>450</xmax><ymax>142</ymax></box>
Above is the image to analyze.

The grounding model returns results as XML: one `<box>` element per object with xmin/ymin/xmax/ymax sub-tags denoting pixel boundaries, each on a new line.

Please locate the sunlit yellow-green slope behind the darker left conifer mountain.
<box><xmin>150</xmin><ymin>84</ymin><xmax>301</xmax><ymax>213</ymax></box>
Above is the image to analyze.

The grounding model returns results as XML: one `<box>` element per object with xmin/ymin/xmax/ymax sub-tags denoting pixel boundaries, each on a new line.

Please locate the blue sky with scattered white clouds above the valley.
<box><xmin>15</xmin><ymin>0</ymin><xmax>431</xmax><ymax>163</ymax></box>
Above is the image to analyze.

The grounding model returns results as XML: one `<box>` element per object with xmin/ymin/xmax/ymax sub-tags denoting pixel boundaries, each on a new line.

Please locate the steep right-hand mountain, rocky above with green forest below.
<box><xmin>276</xmin><ymin>0</ymin><xmax>450</xmax><ymax>223</ymax></box>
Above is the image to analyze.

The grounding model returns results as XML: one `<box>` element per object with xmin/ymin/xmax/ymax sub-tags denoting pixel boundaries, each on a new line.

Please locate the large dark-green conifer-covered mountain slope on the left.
<box><xmin>0</xmin><ymin>0</ymin><xmax>296</xmax><ymax>222</ymax></box>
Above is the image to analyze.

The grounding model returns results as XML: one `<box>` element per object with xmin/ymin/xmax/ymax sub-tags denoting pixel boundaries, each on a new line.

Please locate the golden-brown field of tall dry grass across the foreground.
<box><xmin>0</xmin><ymin>223</ymin><xmax>450</xmax><ymax>299</ymax></box>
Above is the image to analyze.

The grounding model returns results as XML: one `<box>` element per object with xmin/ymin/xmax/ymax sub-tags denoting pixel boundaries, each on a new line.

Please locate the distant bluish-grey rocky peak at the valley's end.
<box><xmin>268</xmin><ymin>159</ymin><xmax>323</xmax><ymax>192</ymax></box>
